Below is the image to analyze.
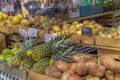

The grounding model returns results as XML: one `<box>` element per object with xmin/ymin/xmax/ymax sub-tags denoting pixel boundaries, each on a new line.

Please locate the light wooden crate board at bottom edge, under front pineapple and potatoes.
<box><xmin>28</xmin><ymin>71</ymin><xmax>58</xmax><ymax>80</ymax></box>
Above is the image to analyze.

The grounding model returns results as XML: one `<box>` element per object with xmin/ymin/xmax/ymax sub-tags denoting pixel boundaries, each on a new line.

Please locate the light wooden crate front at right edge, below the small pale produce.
<box><xmin>95</xmin><ymin>36</ymin><xmax>120</xmax><ymax>48</ymax></box>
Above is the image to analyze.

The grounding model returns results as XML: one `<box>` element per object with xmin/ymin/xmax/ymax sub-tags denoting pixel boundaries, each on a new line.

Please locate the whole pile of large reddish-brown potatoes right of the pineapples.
<box><xmin>45</xmin><ymin>54</ymin><xmax>120</xmax><ymax>80</ymax></box>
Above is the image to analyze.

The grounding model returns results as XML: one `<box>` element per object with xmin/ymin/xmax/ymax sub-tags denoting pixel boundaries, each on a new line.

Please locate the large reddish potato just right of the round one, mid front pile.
<box><xmin>87</xmin><ymin>62</ymin><xmax>105</xmax><ymax>77</ymax></box>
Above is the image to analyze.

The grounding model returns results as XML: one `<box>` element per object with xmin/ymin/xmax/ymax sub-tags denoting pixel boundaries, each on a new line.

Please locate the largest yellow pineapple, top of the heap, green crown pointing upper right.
<box><xmin>30</xmin><ymin>36</ymin><xmax>70</xmax><ymax>62</ymax></box>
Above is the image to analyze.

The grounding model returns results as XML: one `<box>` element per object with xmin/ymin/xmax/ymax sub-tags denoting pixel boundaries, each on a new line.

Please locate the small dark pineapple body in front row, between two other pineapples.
<box><xmin>21</xmin><ymin>57</ymin><xmax>35</xmax><ymax>70</ymax></box>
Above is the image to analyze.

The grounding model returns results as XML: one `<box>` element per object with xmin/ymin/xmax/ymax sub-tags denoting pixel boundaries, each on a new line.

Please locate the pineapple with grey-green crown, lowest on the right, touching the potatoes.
<box><xmin>33</xmin><ymin>47</ymin><xmax>75</xmax><ymax>74</ymax></box>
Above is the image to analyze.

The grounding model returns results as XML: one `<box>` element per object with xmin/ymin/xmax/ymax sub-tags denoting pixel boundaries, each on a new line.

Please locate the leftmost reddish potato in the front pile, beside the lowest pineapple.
<box><xmin>45</xmin><ymin>66</ymin><xmax>62</xmax><ymax>78</ymax></box>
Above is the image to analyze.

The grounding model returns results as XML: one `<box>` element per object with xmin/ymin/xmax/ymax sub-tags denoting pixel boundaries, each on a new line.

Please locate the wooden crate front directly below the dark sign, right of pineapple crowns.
<box><xmin>71</xmin><ymin>35</ymin><xmax>95</xmax><ymax>45</ymax></box>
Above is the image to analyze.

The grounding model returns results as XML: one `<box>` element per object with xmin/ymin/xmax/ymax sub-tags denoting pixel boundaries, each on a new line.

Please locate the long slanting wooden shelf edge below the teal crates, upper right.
<box><xmin>68</xmin><ymin>11</ymin><xmax>114</xmax><ymax>22</ymax></box>
